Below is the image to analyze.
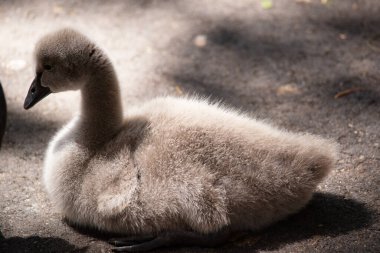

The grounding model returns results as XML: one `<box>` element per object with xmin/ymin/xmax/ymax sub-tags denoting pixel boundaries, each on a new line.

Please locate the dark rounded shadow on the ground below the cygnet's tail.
<box><xmin>246</xmin><ymin>193</ymin><xmax>374</xmax><ymax>250</ymax></box>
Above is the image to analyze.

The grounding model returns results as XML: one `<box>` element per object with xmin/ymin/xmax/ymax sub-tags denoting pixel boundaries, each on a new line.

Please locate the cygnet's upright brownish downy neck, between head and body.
<box><xmin>77</xmin><ymin>59</ymin><xmax>123</xmax><ymax>149</ymax></box>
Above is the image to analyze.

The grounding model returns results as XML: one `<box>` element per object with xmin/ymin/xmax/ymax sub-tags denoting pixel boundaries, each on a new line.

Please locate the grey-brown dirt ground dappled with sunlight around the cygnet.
<box><xmin>0</xmin><ymin>0</ymin><xmax>380</xmax><ymax>252</ymax></box>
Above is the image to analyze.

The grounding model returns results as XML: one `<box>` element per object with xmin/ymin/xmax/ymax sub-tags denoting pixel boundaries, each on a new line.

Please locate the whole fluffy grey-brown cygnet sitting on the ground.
<box><xmin>24</xmin><ymin>29</ymin><xmax>336</xmax><ymax>251</ymax></box>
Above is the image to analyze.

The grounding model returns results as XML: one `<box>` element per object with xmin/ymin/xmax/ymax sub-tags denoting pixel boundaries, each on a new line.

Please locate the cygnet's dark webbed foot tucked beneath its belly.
<box><xmin>109</xmin><ymin>231</ymin><xmax>231</xmax><ymax>252</ymax></box>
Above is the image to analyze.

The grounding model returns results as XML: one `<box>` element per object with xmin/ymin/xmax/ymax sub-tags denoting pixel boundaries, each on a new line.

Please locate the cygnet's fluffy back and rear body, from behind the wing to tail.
<box><xmin>115</xmin><ymin>97</ymin><xmax>336</xmax><ymax>233</ymax></box>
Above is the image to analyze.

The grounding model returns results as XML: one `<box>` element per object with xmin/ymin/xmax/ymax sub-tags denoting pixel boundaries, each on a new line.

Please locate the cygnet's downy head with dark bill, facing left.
<box><xmin>24</xmin><ymin>29</ymin><xmax>99</xmax><ymax>109</ymax></box>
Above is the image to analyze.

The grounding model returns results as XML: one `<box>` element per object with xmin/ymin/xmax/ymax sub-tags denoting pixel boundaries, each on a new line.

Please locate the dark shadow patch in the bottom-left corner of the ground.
<box><xmin>0</xmin><ymin>236</ymin><xmax>87</xmax><ymax>253</ymax></box>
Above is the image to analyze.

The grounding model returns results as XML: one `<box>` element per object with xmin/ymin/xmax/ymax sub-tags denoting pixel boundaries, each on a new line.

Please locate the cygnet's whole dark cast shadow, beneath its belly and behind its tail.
<box><xmin>66</xmin><ymin>193</ymin><xmax>373</xmax><ymax>253</ymax></box>
